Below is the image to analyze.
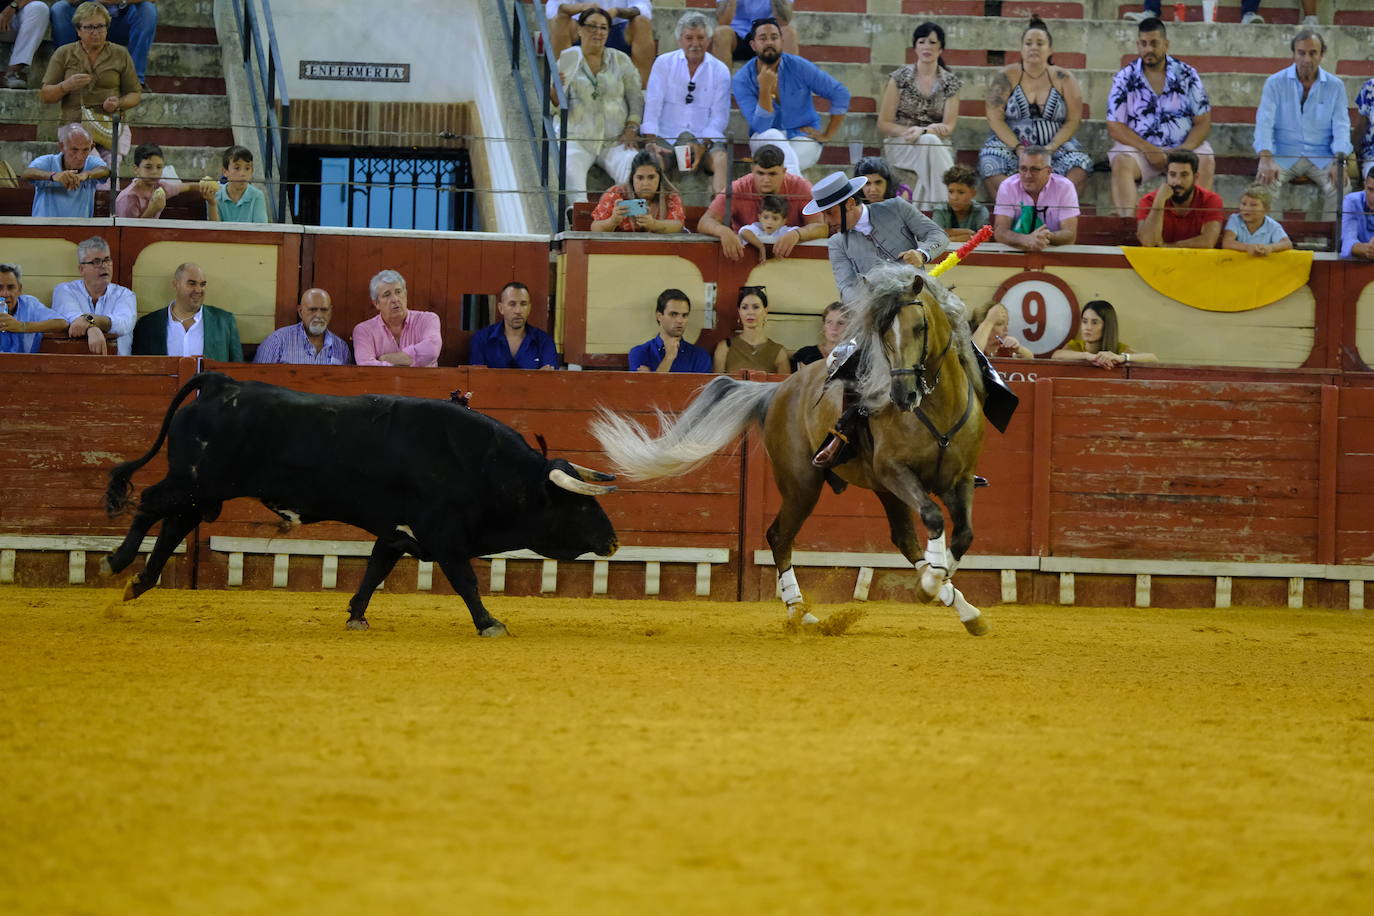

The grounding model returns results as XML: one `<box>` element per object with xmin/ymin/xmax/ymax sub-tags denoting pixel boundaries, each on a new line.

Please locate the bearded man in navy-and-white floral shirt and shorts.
<box><xmin>1107</xmin><ymin>18</ymin><xmax>1216</xmax><ymax>216</ymax></box>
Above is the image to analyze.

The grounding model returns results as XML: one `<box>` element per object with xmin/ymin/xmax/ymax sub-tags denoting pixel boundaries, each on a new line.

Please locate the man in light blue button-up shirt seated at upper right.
<box><xmin>1254</xmin><ymin>29</ymin><xmax>1352</xmax><ymax>218</ymax></box>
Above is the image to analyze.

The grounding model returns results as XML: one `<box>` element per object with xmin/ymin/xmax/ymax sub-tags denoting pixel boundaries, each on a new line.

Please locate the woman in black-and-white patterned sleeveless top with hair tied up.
<box><xmin>978</xmin><ymin>18</ymin><xmax>1092</xmax><ymax>198</ymax></box>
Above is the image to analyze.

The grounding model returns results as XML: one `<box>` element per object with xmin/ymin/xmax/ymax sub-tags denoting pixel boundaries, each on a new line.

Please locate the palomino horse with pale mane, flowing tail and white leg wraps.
<box><xmin>592</xmin><ymin>264</ymin><xmax>987</xmax><ymax>636</ymax></box>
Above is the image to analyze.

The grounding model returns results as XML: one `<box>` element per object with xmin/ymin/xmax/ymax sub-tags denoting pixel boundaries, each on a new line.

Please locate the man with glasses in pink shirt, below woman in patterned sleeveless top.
<box><xmin>992</xmin><ymin>147</ymin><xmax>1079</xmax><ymax>251</ymax></box>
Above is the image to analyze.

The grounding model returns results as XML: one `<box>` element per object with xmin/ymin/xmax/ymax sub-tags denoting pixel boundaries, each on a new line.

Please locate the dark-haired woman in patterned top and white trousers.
<box><xmin>878</xmin><ymin>22</ymin><xmax>963</xmax><ymax>210</ymax></box>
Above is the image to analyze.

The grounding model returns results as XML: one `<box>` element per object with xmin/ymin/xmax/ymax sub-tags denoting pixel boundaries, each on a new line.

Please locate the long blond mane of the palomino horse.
<box><xmin>845</xmin><ymin>264</ymin><xmax>981</xmax><ymax>412</ymax></box>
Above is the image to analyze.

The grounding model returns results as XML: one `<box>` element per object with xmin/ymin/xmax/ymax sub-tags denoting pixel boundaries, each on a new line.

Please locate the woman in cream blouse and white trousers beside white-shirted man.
<box><xmin>558</xmin><ymin>7</ymin><xmax>644</xmax><ymax>201</ymax></box>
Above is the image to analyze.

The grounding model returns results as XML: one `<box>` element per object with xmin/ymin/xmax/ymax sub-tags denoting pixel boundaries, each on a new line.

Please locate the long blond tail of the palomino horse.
<box><xmin>591</xmin><ymin>376</ymin><xmax>778</xmax><ymax>481</ymax></box>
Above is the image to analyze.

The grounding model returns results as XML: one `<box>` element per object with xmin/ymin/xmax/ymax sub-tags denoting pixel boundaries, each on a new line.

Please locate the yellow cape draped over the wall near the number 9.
<box><xmin>1121</xmin><ymin>247</ymin><xmax>1312</xmax><ymax>312</ymax></box>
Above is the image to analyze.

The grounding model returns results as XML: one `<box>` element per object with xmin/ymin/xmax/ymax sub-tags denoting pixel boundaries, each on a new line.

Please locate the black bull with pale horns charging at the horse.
<box><xmin>104</xmin><ymin>372</ymin><xmax>617</xmax><ymax>636</ymax></box>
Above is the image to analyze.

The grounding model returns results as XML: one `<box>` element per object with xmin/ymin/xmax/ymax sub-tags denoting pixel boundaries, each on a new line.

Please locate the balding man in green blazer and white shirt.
<box><xmin>133</xmin><ymin>264</ymin><xmax>243</xmax><ymax>363</ymax></box>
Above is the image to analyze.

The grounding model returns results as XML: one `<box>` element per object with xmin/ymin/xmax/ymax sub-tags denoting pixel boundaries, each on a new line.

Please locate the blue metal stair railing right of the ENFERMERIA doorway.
<box><xmin>502</xmin><ymin>0</ymin><xmax>567</xmax><ymax>233</ymax></box>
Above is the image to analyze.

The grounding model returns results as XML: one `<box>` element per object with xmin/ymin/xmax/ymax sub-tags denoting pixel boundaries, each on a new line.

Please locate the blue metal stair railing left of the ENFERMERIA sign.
<box><xmin>234</xmin><ymin>0</ymin><xmax>291</xmax><ymax>222</ymax></box>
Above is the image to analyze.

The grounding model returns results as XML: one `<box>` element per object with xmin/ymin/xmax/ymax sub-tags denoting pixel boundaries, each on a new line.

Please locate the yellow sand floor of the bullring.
<box><xmin>0</xmin><ymin>586</ymin><xmax>1374</xmax><ymax>915</ymax></box>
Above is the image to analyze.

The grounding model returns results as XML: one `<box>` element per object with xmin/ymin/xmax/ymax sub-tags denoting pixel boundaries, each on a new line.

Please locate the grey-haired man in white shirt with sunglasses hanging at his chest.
<box><xmin>642</xmin><ymin>12</ymin><xmax>730</xmax><ymax>194</ymax></box>
